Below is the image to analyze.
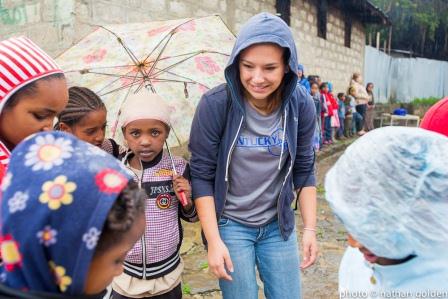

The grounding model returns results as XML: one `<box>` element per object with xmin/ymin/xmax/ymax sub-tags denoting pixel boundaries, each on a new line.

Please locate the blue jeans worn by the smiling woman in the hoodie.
<box><xmin>218</xmin><ymin>218</ymin><xmax>302</xmax><ymax>299</ymax></box>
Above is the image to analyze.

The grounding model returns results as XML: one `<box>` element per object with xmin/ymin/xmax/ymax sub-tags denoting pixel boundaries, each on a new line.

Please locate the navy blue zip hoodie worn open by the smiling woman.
<box><xmin>189</xmin><ymin>13</ymin><xmax>316</xmax><ymax>240</ymax></box>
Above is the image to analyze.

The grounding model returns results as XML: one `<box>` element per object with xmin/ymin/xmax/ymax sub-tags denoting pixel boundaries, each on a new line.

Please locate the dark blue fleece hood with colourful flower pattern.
<box><xmin>1</xmin><ymin>132</ymin><xmax>131</xmax><ymax>295</ymax></box>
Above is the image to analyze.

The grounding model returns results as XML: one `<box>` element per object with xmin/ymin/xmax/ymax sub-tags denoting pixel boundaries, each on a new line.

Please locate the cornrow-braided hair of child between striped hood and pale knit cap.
<box><xmin>55</xmin><ymin>86</ymin><xmax>106</xmax><ymax>130</ymax></box>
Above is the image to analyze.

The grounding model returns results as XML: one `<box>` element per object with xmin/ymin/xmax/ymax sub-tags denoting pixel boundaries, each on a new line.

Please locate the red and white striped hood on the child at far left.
<box><xmin>0</xmin><ymin>36</ymin><xmax>63</xmax><ymax>113</ymax></box>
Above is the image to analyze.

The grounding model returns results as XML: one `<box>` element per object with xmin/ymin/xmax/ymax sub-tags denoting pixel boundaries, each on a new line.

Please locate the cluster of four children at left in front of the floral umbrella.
<box><xmin>0</xmin><ymin>38</ymin><xmax>198</xmax><ymax>299</ymax></box>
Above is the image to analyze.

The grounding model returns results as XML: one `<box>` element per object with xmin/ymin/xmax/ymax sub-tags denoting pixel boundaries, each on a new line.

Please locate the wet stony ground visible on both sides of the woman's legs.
<box><xmin>181</xmin><ymin>140</ymin><xmax>352</xmax><ymax>299</ymax></box>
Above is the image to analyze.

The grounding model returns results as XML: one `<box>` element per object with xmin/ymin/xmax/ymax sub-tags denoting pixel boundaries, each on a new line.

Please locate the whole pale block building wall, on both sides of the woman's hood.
<box><xmin>0</xmin><ymin>0</ymin><xmax>365</xmax><ymax>92</ymax></box>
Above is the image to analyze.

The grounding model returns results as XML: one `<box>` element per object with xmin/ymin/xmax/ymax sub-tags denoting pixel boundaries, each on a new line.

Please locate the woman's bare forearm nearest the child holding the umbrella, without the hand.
<box><xmin>194</xmin><ymin>196</ymin><xmax>220</xmax><ymax>243</ymax></box>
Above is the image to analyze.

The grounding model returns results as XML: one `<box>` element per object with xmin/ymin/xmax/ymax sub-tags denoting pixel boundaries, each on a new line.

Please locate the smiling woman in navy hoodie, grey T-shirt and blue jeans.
<box><xmin>189</xmin><ymin>13</ymin><xmax>317</xmax><ymax>299</ymax></box>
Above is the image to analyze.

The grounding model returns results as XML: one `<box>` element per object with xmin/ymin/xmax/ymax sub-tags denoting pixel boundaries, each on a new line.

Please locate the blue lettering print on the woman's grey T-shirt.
<box><xmin>236</xmin><ymin>128</ymin><xmax>288</xmax><ymax>156</ymax></box>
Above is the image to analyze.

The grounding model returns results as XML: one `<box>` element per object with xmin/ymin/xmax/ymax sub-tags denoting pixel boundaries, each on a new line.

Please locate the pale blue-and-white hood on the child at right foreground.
<box><xmin>325</xmin><ymin>127</ymin><xmax>448</xmax><ymax>259</ymax></box>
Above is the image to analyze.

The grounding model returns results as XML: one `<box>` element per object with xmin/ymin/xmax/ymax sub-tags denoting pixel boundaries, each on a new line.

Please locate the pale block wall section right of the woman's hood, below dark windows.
<box><xmin>291</xmin><ymin>0</ymin><xmax>365</xmax><ymax>94</ymax></box>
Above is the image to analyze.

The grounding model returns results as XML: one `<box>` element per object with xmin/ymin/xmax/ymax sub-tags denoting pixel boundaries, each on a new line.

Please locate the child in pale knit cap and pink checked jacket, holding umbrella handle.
<box><xmin>111</xmin><ymin>89</ymin><xmax>197</xmax><ymax>299</ymax></box>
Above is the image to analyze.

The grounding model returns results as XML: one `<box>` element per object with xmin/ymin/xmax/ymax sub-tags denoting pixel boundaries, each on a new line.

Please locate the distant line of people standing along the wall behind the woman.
<box><xmin>298</xmin><ymin>65</ymin><xmax>374</xmax><ymax>151</ymax></box>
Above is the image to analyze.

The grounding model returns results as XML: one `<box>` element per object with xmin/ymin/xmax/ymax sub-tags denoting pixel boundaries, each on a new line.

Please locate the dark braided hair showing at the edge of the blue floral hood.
<box><xmin>95</xmin><ymin>181</ymin><xmax>146</xmax><ymax>254</ymax></box>
